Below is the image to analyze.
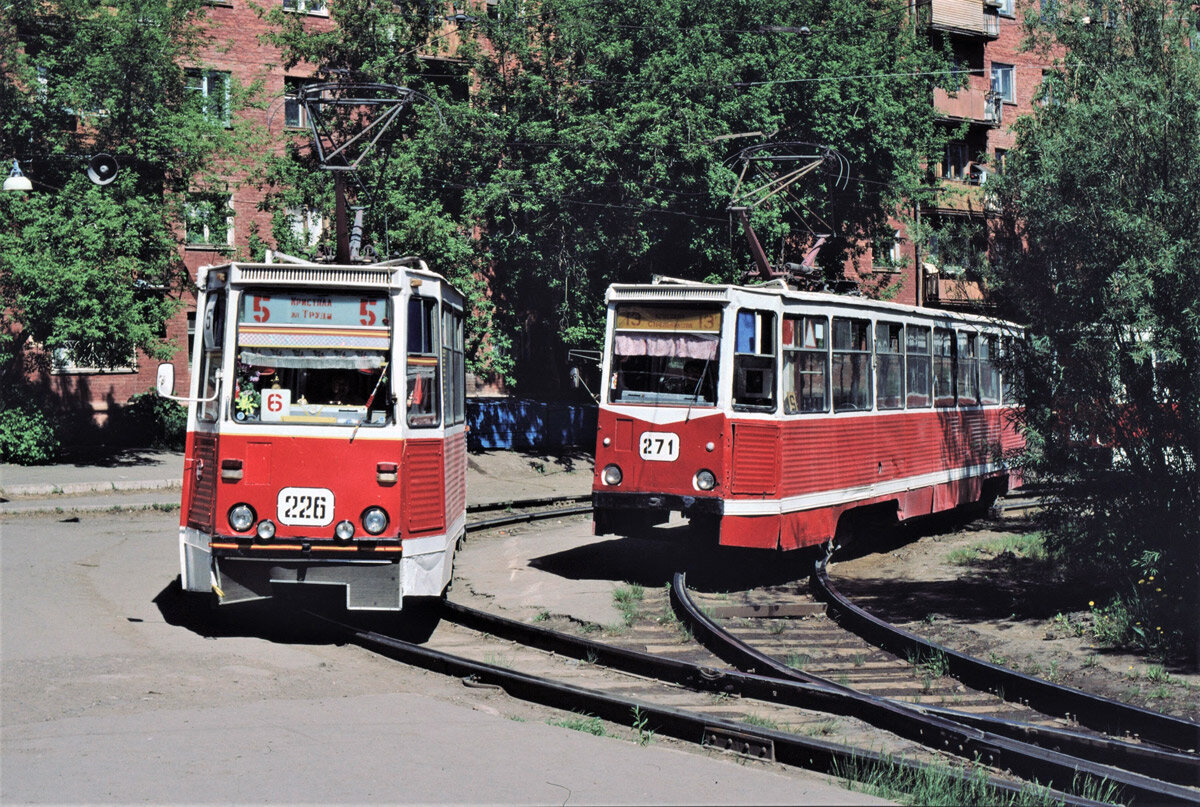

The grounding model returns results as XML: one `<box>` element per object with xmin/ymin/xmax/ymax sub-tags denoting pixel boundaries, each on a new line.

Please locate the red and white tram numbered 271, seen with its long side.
<box><xmin>593</xmin><ymin>280</ymin><xmax>1024</xmax><ymax>549</ymax></box>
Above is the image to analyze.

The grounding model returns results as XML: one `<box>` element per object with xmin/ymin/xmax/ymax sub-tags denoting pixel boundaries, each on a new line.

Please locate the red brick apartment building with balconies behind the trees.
<box><xmin>23</xmin><ymin>0</ymin><xmax>1042</xmax><ymax>441</ymax></box>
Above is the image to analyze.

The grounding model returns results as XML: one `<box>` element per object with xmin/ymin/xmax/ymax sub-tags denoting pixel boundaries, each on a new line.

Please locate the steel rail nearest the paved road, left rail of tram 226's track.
<box><xmin>310</xmin><ymin>606</ymin><xmax>1108</xmax><ymax>807</ymax></box>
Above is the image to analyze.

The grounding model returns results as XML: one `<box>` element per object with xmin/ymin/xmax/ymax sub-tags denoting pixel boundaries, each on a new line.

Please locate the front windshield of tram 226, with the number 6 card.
<box><xmin>230</xmin><ymin>289</ymin><xmax>394</xmax><ymax>426</ymax></box>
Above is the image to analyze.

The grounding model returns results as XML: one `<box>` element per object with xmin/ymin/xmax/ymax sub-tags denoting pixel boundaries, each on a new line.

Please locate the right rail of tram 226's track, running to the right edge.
<box><xmin>443</xmin><ymin>595</ymin><xmax>1200</xmax><ymax>805</ymax></box>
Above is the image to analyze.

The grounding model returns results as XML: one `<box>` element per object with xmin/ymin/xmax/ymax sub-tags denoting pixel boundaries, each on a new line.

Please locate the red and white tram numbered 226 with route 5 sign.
<box><xmin>158</xmin><ymin>253</ymin><xmax>467</xmax><ymax>610</ymax></box>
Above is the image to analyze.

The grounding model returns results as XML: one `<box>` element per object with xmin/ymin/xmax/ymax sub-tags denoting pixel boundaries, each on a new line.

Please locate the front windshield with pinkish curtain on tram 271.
<box><xmin>608</xmin><ymin>304</ymin><xmax>721</xmax><ymax>406</ymax></box>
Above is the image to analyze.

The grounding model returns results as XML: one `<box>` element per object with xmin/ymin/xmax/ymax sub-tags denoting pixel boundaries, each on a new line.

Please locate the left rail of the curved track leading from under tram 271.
<box><xmin>671</xmin><ymin>574</ymin><xmax>1200</xmax><ymax>799</ymax></box>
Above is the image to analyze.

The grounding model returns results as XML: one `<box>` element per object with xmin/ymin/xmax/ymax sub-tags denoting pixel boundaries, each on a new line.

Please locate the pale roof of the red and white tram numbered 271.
<box><xmin>605</xmin><ymin>277</ymin><xmax>1022</xmax><ymax>329</ymax></box>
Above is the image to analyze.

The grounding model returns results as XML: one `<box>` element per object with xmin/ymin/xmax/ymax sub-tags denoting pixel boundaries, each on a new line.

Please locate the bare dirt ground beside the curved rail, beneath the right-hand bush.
<box><xmin>829</xmin><ymin>519</ymin><xmax>1200</xmax><ymax>721</ymax></box>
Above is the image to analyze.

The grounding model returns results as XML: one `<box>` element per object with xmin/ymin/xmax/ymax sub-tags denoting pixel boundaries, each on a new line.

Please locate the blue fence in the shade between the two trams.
<box><xmin>467</xmin><ymin>397</ymin><xmax>596</xmax><ymax>452</ymax></box>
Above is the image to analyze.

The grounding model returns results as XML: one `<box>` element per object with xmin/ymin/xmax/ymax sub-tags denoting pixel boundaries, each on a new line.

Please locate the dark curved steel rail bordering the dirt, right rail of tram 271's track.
<box><xmin>811</xmin><ymin>561</ymin><xmax>1200</xmax><ymax>753</ymax></box>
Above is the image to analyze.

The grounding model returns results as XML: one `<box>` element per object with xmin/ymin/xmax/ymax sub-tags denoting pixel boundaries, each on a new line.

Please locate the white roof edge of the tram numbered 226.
<box><xmin>197</xmin><ymin>252</ymin><xmax>461</xmax><ymax>301</ymax></box>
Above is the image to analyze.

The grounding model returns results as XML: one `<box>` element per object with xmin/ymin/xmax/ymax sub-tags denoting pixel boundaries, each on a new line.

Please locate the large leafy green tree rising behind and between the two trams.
<box><xmin>265</xmin><ymin>0</ymin><xmax>950</xmax><ymax>393</ymax></box>
